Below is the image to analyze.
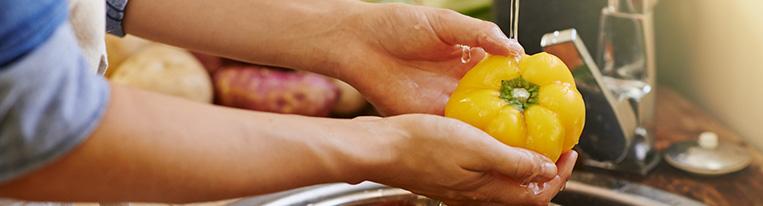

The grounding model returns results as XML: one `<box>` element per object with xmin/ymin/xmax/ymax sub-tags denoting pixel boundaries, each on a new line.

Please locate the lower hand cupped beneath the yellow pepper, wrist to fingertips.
<box><xmin>344</xmin><ymin>114</ymin><xmax>577</xmax><ymax>205</ymax></box>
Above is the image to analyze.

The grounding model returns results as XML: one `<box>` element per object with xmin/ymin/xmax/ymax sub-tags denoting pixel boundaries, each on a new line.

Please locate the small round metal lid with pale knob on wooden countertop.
<box><xmin>665</xmin><ymin>132</ymin><xmax>752</xmax><ymax>175</ymax></box>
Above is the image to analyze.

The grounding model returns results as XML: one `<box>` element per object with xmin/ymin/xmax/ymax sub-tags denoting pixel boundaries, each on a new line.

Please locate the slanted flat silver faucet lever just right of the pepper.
<box><xmin>541</xmin><ymin>29</ymin><xmax>638</xmax><ymax>162</ymax></box>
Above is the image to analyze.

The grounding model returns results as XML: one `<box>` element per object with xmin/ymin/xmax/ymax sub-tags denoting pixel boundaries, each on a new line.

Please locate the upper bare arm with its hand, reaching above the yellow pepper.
<box><xmin>124</xmin><ymin>0</ymin><xmax>524</xmax><ymax>115</ymax></box>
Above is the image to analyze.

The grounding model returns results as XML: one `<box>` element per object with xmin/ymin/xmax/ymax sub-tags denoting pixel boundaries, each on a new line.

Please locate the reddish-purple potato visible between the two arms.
<box><xmin>214</xmin><ymin>65</ymin><xmax>339</xmax><ymax>117</ymax></box>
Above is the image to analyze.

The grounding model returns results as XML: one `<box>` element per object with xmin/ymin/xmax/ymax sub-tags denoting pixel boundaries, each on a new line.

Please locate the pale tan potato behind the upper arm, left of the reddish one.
<box><xmin>110</xmin><ymin>45</ymin><xmax>212</xmax><ymax>103</ymax></box>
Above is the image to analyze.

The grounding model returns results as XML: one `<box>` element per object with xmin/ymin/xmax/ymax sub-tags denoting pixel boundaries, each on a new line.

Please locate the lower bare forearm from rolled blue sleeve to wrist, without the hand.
<box><xmin>0</xmin><ymin>83</ymin><xmax>370</xmax><ymax>202</ymax></box>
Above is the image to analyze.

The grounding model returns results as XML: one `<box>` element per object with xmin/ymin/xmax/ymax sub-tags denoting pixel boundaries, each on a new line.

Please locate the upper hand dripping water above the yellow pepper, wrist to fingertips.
<box><xmin>335</xmin><ymin>4</ymin><xmax>524</xmax><ymax>115</ymax></box>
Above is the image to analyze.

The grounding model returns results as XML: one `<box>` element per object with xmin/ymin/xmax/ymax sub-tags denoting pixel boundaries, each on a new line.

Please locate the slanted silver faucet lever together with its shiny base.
<box><xmin>541</xmin><ymin>29</ymin><xmax>658</xmax><ymax>174</ymax></box>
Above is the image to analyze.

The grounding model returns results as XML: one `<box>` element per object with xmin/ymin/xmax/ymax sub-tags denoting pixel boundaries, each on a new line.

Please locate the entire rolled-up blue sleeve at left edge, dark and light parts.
<box><xmin>0</xmin><ymin>0</ymin><xmax>109</xmax><ymax>183</ymax></box>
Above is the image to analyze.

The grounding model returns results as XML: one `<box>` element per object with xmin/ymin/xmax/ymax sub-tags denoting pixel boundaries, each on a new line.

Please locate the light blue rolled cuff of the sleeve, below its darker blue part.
<box><xmin>0</xmin><ymin>22</ymin><xmax>109</xmax><ymax>183</ymax></box>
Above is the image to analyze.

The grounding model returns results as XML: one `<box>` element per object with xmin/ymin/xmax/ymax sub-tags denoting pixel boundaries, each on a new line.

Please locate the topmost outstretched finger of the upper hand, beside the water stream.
<box><xmin>428</xmin><ymin>9</ymin><xmax>524</xmax><ymax>56</ymax></box>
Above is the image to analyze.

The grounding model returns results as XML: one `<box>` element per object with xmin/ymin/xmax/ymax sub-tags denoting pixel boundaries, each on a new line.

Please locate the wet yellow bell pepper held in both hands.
<box><xmin>445</xmin><ymin>52</ymin><xmax>585</xmax><ymax>161</ymax></box>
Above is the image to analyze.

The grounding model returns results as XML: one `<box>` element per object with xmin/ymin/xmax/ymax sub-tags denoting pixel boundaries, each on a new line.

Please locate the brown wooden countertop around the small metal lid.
<box><xmin>592</xmin><ymin>88</ymin><xmax>763</xmax><ymax>205</ymax></box>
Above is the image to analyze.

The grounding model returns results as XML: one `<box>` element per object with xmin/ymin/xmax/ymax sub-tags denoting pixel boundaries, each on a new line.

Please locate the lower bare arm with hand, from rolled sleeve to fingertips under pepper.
<box><xmin>0</xmin><ymin>83</ymin><xmax>575</xmax><ymax>204</ymax></box>
